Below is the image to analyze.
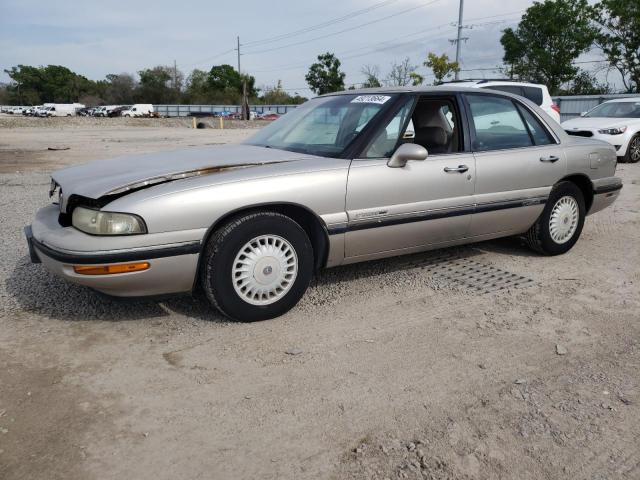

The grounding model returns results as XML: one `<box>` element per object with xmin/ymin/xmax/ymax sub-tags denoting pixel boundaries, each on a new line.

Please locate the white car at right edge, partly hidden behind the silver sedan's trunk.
<box><xmin>562</xmin><ymin>96</ymin><xmax>640</xmax><ymax>163</ymax></box>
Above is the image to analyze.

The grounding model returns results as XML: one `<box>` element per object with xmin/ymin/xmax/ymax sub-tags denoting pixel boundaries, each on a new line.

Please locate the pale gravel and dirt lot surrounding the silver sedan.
<box><xmin>0</xmin><ymin>124</ymin><xmax>640</xmax><ymax>480</ymax></box>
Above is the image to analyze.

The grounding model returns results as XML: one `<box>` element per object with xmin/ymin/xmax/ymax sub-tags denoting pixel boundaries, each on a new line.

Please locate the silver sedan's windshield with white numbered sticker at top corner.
<box><xmin>245</xmin><ymin>95</ymin><xmax>394</xmax><ymax>157</ymax></box>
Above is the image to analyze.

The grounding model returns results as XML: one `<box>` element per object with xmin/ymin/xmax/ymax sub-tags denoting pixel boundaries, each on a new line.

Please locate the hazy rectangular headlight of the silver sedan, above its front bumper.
<box><xmin>71</xmin><ymin>207</ymin><xmax>147</xmax><ymax>235</ymax></box>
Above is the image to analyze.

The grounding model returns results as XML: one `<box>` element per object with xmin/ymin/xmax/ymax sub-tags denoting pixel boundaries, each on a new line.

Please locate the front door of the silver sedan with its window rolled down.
<box><xmin>345</xmin><ymin>96</ymin><xmax>475</xmax><ymax>258</ymax></box>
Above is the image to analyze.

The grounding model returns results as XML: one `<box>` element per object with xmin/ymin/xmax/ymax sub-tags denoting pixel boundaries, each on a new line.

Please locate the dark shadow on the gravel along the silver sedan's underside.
<box><xmin>5</xmin><ymin>239</ymin><xmax>536</xmax><ymax>323</ymax></box>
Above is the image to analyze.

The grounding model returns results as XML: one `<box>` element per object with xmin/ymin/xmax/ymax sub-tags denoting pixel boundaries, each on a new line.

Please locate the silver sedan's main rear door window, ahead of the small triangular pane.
<box><xmin>467</xmin><ymin>94</ymin><xmax>533</xmax><ymax>151</ymax></box>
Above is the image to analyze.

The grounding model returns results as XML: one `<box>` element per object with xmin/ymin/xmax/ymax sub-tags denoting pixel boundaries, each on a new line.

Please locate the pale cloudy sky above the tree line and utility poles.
<box><xmin>0</xmin><ymin>0</ymin><xmax>615</xmax><ymax>96</ymax></box>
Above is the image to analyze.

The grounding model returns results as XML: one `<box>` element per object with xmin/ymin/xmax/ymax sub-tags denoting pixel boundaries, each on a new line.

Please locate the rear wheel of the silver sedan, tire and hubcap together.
<box><xmin>524</xmin><ymin>182</ymin><xmax>586</xmax><ymax>255</ymax></box>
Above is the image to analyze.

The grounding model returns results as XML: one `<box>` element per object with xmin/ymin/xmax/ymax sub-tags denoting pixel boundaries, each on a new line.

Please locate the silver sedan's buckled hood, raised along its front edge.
<box><xmin>51</xmin><ymin>145</ymin><xmax>319</xmax><ymax>200</ymax></box>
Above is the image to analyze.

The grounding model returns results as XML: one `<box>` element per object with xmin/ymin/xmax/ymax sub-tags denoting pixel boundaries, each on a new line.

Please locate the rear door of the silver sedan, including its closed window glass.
<box><xmin>465</xmin><ymin>92</ymin><xmax>566</xmax><ymax>236</ymax></box>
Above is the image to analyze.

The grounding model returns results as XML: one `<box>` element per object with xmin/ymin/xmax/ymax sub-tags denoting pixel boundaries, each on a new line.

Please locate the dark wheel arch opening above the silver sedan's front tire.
<box><xmin>194</xmin><ymin>202</ymin><xmax>329</xmax><ymax>286</ymax></box>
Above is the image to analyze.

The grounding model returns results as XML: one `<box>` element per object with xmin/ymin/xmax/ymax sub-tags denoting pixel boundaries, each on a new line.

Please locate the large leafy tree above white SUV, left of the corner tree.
<box><xmin>500</xmin><ymin>0</ymin><xmax>596</xmax><ymax>95</ymax></box>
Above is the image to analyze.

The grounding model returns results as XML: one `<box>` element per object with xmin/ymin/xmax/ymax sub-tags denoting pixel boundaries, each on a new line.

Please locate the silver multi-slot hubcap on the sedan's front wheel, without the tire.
<box><xmin>231</xmin><ymin>235</ymin><xmax>298</xmax><ymax>305</ymax></box>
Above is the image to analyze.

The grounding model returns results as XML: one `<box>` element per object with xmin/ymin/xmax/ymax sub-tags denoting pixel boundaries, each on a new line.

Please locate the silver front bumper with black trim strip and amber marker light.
<box><xmin>25</xmin><ymin>206</ymin><xmax>204</xmax><ymax>297</ymax></box>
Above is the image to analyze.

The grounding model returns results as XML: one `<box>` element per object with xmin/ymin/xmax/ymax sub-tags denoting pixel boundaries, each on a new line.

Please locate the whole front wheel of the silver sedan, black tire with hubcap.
<box><xmin>200</xmin><ymin>211</ymin><xmax>314</xmax><ymax>322</ymax></box>
